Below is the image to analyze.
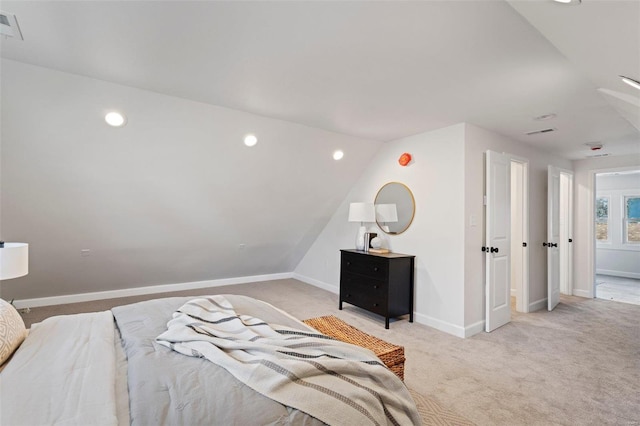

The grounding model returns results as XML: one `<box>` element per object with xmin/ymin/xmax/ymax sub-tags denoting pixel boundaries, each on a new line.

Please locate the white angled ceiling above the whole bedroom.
<box><xmin>0</xmin><ymin>0</ymin><xmax>640</xmax><ymax>158</ymax></box>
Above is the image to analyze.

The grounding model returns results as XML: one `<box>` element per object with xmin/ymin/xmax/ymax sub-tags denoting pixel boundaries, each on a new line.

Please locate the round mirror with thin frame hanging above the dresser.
<box><xmin>374</xmin><ymin>182</ymin><xmax>416</xmax><ymax>235</ymax></box>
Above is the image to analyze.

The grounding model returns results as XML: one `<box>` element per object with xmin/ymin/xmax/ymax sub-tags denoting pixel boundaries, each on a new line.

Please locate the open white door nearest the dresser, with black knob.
<box><xmin>484</xmin><ymin>151</ymin><xmax>511</xmax><ymax>331</ymax></box>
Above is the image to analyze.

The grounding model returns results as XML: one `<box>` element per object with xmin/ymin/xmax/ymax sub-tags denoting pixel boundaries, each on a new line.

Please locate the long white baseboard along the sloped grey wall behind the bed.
<box><xmin>13</xmin><ymin>272</ymin><xmax>293</xmax><ymax>309</ymax></box>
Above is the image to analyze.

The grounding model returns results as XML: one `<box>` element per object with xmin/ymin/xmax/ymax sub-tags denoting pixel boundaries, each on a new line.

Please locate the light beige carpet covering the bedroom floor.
<box><xmin>24</xmin><ymin>280</ymin><xmax>640</xmax><ymax>425</ymax></box>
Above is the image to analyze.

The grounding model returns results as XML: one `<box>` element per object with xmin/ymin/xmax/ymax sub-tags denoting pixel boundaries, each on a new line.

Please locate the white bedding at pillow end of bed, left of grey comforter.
<box><xmin>0</xmin><ymin>311</ymin><xmax>120</xmax><ymax>426</ymax></box>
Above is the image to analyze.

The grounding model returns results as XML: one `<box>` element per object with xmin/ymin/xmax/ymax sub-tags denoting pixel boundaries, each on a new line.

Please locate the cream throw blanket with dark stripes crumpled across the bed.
<box><xmin>156</xmin><ymin>295</ymin><xmax>421</xmax><ymax>425</ymax></box>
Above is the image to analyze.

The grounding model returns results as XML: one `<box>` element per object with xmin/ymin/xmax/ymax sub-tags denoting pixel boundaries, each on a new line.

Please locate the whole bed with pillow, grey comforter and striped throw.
<box><xmin>0</xmin><ymin>295</ymin><xmax>420</xmax><ymax>426</ymax></box>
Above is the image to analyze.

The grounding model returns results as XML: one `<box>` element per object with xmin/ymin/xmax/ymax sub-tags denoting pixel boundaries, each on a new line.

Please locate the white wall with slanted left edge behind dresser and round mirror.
<box><xmin>295</xmin><ymin>124</ymin><xmax>465</xmax><ymax>336</ymax></box>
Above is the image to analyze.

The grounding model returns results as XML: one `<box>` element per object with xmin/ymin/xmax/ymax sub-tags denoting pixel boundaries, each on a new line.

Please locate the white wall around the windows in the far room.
<box><xmin>596</xmin><ymin>173</ymin><xmax>640</xmax><ymax>278</ymax></box>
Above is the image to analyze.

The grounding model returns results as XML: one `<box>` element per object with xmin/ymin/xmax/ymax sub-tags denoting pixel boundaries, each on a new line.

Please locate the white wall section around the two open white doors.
<box><xmin>464</xmin><ymin>124</ymin><xmax>572</xmax><ymax>334</ymax></box>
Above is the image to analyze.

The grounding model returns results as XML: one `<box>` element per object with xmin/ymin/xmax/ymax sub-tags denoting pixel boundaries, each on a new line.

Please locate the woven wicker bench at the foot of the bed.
<box><xmin>303</xmin><ymin>315</ymin><xmax>405</xmax><ymax>380</ymax></box>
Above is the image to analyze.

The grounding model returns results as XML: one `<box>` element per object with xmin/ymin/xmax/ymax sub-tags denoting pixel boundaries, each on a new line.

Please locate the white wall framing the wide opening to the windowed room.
<box><xmin>573</xmin><ymin>154</ymin><xmax>640</xmax><ymax>297</ymax></box>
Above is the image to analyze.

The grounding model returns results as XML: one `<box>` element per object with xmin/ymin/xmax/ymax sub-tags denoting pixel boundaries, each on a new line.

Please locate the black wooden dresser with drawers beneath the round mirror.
<box><xmin>339</xmin><ymin>250</ymin><xmax>415</xmax><ymax>328</ymax></box>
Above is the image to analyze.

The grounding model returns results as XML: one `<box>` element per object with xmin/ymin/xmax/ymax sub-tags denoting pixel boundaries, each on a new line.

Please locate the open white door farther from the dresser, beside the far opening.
<box><xmin>543</xmin><ymin>166</ymin><xmax>560</xmax><ymax>311</ymax></box>
